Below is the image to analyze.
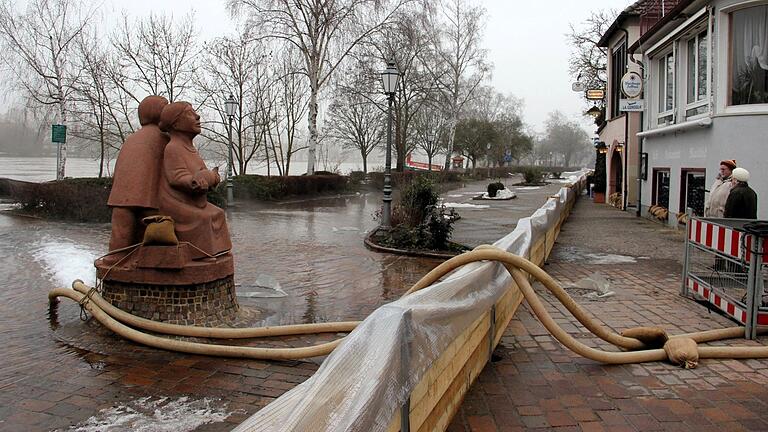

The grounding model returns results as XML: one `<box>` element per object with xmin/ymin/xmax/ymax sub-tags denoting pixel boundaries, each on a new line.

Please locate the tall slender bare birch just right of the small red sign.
<box><xmin>424</xmin><ymin>0</ymin><xmax>490</xmax><ymax>169</ymax></box>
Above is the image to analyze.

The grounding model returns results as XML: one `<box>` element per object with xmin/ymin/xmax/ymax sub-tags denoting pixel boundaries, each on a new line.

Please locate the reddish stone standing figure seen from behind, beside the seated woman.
<box><xmin>107</xmin><ymin>96</ymin><xmax>168</xmax><ymax>251</ymax></box>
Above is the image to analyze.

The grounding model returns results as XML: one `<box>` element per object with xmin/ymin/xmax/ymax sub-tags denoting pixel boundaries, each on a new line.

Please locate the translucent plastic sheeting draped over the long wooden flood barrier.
<box><xmin>234</xmin><ymin>170</ymin><xmax>587</xmax><ymax>432</ymax></box>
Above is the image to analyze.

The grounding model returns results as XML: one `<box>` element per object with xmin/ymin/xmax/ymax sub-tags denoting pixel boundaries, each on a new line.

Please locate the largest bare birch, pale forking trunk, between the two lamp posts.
<box><xmin>227</xmin><ymin>0</ymin><xmax>410</xmax><ymax>174</ymax></box>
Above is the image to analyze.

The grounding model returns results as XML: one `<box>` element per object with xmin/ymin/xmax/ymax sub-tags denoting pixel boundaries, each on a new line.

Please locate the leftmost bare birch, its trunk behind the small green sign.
<box><xmin>0</xmin><ymin>0</ymin><xmax>92</xmax><ymax>179</ymax></box>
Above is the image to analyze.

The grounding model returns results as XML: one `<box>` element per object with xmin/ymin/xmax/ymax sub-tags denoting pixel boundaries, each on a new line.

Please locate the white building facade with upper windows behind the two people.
<box><xmin>630</xmin><ymin>0</ymin><xmax>768</xmax><ymax>225</ymax></box>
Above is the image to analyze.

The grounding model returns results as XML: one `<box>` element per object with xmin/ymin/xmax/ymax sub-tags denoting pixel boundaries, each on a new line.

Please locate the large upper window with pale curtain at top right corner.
<box><xmin>730</xmin><ymin>5</ymin><xmax>768</xmax><ymax>105</ymax></box>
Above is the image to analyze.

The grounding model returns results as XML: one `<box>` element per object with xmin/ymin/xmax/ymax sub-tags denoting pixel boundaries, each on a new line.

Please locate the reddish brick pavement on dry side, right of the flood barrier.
<box><xmin>448</xmin><ymin>199</ymin><xmax>768</xmax><ymax>432</ymax></box>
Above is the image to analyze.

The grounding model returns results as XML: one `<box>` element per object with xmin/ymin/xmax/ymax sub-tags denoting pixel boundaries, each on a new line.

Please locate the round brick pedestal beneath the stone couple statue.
<box><xmin>102</xmin><ymin>276</ymin><xmax>239</xmax><ymax>326</ymax></box>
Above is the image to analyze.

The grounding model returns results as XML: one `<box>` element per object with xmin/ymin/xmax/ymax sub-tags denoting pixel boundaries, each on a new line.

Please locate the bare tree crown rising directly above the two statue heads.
<box><xmin>112</xmin><ymin>13</ymin><xmax>198</xmax><ymax>103</ymax></box>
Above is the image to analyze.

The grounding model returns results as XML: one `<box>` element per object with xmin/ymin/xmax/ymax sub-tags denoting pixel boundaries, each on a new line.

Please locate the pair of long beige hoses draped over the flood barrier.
<box><xmin>48</xmin><ymin>245</ymin><xmax>768</xmax><ymax>364</ymax></box>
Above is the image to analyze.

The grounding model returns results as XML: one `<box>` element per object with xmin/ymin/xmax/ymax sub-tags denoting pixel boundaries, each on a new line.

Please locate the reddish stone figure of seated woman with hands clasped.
<box><xmin>158</xmin><ymin>102</ymin><xmax>232</xmax><ymax>258</ymax></box>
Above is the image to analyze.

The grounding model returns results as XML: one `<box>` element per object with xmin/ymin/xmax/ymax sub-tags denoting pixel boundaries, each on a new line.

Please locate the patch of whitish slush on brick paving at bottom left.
<box><xmin>67</xmin><ymin>396</ymin><xmax>233</xmax><ymax>432</ymax></box>
